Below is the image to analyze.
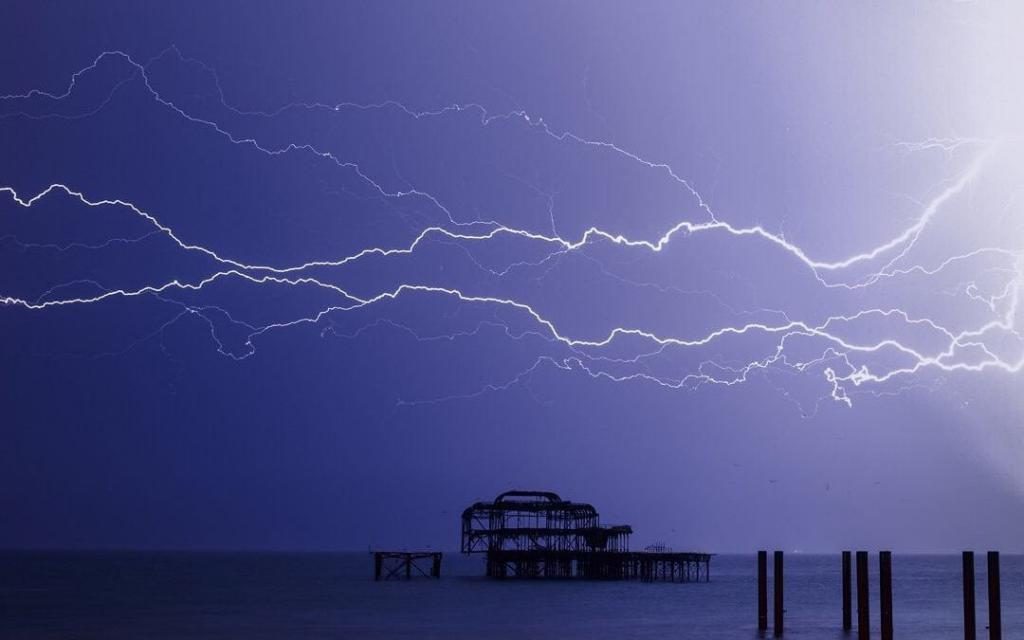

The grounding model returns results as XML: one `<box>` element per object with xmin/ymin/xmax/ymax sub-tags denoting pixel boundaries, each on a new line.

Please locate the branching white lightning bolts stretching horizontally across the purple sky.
<box><xmin>0</xmin><ymin>47</ymin><xmax>1024</xmax><ymax>413</ymax></box>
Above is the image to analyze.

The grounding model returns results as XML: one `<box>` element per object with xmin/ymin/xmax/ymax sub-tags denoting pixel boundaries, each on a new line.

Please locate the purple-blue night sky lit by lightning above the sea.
<box><xmin>0</xmin><ymin>0</ymin><xmax>1024</xmax><ymax>552</ymax></box>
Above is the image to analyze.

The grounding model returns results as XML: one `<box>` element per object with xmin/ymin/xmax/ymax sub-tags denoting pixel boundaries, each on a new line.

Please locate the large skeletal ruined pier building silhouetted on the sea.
<box><xmin>462</xmin><ymin>492</ymin><xmax>711</xmax><ymax>583</ymax></box>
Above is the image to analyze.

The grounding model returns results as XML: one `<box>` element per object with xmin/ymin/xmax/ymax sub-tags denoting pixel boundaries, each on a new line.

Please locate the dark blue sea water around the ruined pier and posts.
<box><xmin>0</xmin><ymin>552</ymin><xmax>1024</xmax><ymax>640</ymax></box>
